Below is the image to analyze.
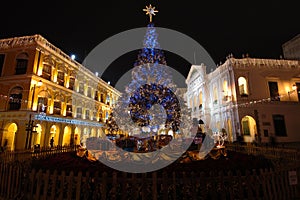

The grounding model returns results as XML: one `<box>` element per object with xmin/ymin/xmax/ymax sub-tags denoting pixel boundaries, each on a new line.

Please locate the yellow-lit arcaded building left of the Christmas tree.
<box><xmin>0</xmin><ymin>35</ymin><xmax>120</xmax><ymax>150</ymax></box>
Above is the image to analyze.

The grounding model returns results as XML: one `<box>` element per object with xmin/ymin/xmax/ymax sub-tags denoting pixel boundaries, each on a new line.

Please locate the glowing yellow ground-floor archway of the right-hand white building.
<box><xmin>241</xmin><ymin>115</ymin><xmax>257</xmax><ymax>142</ymax></box>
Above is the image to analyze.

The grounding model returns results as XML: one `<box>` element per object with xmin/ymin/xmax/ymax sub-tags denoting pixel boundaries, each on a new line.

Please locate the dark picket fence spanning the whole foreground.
<box><xmin>0</xmin><ymin>163</ymin><xmax>300</xmax><ymax>200</ymax></box>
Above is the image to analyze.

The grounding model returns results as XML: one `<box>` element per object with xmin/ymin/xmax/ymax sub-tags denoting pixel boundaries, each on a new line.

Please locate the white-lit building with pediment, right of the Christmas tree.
<box><xmin>186</xmin><ymin>58</ymin><xmax>300</xmax><ymax>142</ymax></box>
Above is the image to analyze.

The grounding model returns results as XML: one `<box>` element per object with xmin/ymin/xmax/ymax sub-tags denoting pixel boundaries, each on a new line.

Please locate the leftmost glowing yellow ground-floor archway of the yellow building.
<box><xmin>1</xmin><ymin>123</ymin><xmax>18</xmax><ymax>151</ymax></box>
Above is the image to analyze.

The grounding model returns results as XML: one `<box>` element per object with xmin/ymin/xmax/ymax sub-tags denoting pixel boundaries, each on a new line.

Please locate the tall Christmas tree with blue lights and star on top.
<box><xmin>109</xmin><ymin>5</ymin><xmax>190</xmax><ymax>139</ymax></box>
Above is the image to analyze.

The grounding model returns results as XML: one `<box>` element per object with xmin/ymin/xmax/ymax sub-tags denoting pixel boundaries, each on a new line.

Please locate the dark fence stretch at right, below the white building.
<box><xmin>226</xmin><ymin>144</ymin><xmax>300</xmax><ymax>162</ymax></box>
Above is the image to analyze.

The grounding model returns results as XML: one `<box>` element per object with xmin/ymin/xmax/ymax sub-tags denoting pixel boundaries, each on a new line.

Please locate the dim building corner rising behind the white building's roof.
<box><xmin>282</xmin><ymin>34</ymin><xmax>300</xmax><ymax>60</ymax></box>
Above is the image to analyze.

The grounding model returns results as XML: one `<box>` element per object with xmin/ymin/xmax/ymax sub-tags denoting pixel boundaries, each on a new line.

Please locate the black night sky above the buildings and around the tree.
<box><xmin>0</xmin><ymin>0</ymin><xmax>300</xmax><ymax>84</ymax></box>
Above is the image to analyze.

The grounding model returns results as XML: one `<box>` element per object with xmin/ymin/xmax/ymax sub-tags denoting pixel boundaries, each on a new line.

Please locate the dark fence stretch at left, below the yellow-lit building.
<box><xmin>0</xmin><ymin>146</ymin><xmax>76</xmax><ymax>162</ymax></box>
